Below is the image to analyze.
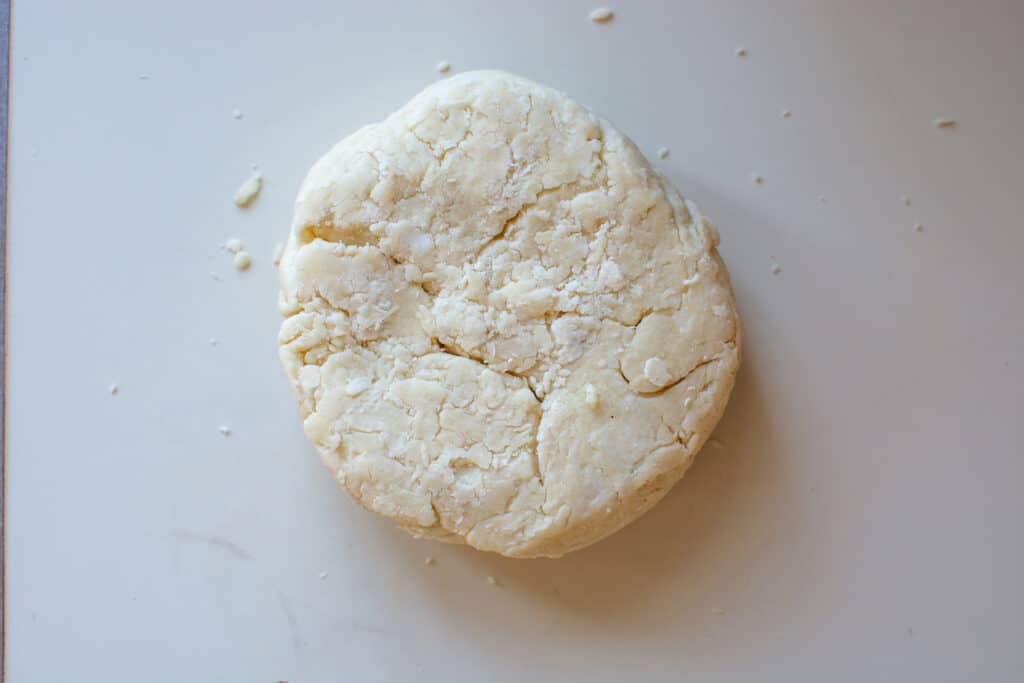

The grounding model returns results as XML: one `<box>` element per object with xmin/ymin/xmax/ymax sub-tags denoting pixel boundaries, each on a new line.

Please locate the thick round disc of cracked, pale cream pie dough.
<box><xmin>280</xmin><ymin>72</ymin><xmax>740</xmax><ymax>557</ymax></box>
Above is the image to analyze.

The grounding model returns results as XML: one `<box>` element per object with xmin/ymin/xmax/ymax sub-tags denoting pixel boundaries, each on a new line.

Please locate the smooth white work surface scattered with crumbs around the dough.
<box><xmin>6</xmin><ymin>0</ymin><xmax>1024</xmax><ymax>683</ymax></box>
